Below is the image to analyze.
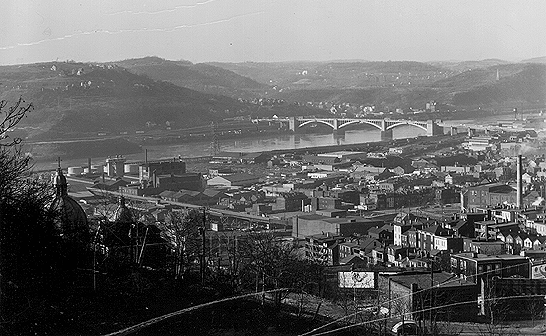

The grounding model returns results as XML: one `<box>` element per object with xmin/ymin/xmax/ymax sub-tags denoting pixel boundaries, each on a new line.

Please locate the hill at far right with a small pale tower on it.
<box><xmin>268</xmin><ymin>63</ymin><xmax>546</xmax><ymax>109</ymax></box>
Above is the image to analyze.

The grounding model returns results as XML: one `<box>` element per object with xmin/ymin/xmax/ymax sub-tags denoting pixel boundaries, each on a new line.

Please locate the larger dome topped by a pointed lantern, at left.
<box><xmin>51</xmin><ymin>167</ymin><xmax>89</xmax><ymax>244</ymax></box>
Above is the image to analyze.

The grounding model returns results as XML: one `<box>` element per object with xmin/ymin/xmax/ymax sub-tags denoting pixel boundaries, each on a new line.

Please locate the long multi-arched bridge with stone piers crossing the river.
<box><xmin>253</xmin><ymin>117</ymin><xmax>443</xmax><ymax>140</ymax></box>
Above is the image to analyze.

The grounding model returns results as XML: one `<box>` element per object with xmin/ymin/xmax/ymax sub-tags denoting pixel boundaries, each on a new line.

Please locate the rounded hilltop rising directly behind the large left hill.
<box><xmin>115</xmin><ymin>57</ymin><xmax>269</xmax><ymax>98</ymax></box>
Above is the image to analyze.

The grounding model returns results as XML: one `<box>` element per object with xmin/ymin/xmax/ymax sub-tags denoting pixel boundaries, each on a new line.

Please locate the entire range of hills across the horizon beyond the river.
<box><xmin>0</xmin><ymin>57</ymin><xmax>546</xmax><ymax>140</ymax></box>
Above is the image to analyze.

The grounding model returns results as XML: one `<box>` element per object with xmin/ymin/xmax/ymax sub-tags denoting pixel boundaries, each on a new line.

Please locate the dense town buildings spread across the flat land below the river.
<box><xmin>63</xmin><ymin>128</ymin><xmax>546</xmax><ymax>321</ymax></box>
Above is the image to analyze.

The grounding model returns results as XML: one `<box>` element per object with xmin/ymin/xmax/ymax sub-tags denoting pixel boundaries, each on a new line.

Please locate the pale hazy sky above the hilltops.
<box><xmin>0</xmin><ymin>0</ymin><xmax>546</xmax><ymax>64</ymax></box>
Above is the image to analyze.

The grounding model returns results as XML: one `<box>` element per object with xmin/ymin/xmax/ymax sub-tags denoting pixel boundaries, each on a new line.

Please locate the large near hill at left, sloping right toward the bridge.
<box><xmin>0</xmin><ymin>62</ymin><xmax>247</xmax><ymax>138</ymax></box>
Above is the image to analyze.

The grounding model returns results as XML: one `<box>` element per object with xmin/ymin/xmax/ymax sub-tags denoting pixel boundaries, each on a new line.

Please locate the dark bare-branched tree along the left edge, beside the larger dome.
<box><xmin>0</xmin><ymin>98</ymin><xmax>65</xmax><ymax>334</ymax></box>
